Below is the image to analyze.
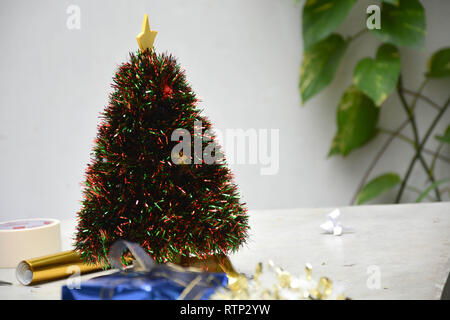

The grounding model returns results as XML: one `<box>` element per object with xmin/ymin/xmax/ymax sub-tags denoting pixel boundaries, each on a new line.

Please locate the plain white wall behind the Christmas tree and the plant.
<box><xmin>0</xmin><ymin>0</ymin><xmax>450</xmax><ymax>220</ymax></box>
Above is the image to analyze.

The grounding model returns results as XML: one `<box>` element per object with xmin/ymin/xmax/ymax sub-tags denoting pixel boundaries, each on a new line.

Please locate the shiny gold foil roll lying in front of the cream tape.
<box><xmin>16</xmin><ymin>250</ymin><xmax>102</xmax><ymax>286</ymax></box>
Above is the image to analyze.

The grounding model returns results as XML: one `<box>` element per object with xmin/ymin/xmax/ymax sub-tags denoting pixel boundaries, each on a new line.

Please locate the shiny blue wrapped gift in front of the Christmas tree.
<box><xmin>62</xmin><ymin>243</ymin><xmax>228</xmax><ymax>300</ymax></box>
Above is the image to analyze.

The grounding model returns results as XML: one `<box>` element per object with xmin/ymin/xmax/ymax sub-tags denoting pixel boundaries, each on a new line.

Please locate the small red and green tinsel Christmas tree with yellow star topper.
<box><xmin>75</xmin><ymin>15</ymin><xmax>248</xmax><ymax>266</ymax></box>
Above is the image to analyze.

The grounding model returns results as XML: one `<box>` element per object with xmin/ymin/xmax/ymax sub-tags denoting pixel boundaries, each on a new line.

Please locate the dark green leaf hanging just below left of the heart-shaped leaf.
<box><xmin>329</xmin><ymin>86</ymin><xmax>379</xmax><ymax>156</ymax></box>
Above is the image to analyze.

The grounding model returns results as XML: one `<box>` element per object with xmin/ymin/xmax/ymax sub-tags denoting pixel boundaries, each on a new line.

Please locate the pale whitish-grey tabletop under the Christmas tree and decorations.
<box><xmin>0</xmin><ymin>202</ymin><xmax>450</xmax><ymax>299</ymax></box>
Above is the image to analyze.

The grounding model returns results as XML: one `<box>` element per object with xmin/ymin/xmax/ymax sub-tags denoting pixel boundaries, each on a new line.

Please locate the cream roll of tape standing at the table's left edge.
<box><xmin>0</xmin><ymin>219</ymin><xmax>61</xmax><ymax>268</ymax></box>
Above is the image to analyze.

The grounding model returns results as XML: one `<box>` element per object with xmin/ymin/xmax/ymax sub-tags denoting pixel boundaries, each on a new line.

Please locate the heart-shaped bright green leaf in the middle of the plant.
<box><xmin>353</xmin><ymin>44</ymin><xmax>400</xmax><ymax>106</ymax></box>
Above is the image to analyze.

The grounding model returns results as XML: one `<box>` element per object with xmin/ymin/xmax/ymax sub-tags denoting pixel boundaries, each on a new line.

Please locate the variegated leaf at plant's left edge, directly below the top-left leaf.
<box><xmin>300</xmin><ymin>34</ymin><xmax>347</xmax><ymax>103</ymax></box>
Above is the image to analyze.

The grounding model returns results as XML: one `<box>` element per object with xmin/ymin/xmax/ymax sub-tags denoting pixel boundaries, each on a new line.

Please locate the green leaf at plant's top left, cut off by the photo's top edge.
<box><xmin>302</xmin><ymin>0</ymin><xmax>356</xmax><ymax>50</ymax></box>
